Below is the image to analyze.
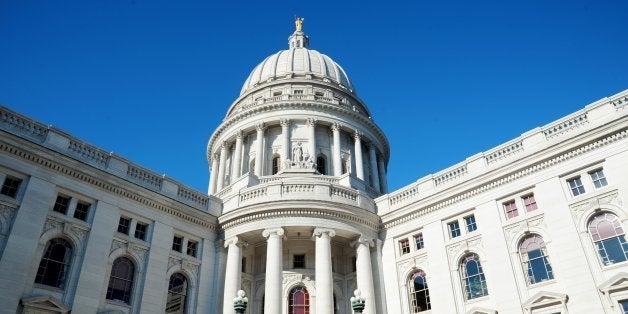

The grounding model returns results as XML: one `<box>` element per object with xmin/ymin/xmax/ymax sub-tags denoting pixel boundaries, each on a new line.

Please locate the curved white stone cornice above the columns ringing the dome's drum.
<box><xmin>206</xmin><ymin>100</ymin><xmax>390</xmax><ymax>160</ymax></box>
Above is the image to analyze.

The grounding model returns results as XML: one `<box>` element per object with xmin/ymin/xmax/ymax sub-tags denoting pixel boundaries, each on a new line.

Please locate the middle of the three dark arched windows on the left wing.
<box><xmin>107</xmin><ymin>257</ymin><xmax>135</xmax><ymax>303</ymax></box>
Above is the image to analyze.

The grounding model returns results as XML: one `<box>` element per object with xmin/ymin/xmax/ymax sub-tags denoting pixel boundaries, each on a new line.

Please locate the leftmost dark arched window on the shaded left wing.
<box><xmin>35</xmin><ymin>239</ymin><xmax>72</xmax><ymax>289</ymax></box>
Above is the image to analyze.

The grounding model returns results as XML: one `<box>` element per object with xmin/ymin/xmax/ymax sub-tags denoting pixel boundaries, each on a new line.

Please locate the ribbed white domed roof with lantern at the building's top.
<box><xmin>240</xmin><ymin>25</ymin><xmax>355</xmax><ymax>96</ymax></box>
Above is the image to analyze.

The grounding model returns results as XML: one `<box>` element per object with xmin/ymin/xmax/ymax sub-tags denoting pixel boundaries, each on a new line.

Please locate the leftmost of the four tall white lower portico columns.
<box><xmin>222</xmin><ymin>237</ymin><xmax>246</xmax><ymax>314</ymax></box>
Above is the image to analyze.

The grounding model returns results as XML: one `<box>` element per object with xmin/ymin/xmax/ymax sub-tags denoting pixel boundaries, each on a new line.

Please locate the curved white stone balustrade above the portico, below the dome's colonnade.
<box><xmin>223</xmin><ymin>178</ymin><xmax>375</xmax><ymax>213</ymax></box>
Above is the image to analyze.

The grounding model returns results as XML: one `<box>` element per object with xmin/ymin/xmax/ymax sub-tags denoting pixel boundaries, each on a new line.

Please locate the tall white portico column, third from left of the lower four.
<box><xmin>312</xmin><ymin>228</ymin><xmax>336</xmax><ymax>314</ymax></box>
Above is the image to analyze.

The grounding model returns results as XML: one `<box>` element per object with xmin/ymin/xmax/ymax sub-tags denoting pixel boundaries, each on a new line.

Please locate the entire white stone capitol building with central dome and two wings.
<box><xmin>0</xmin><ymin>18</ymin><xmax>628</xmax><ymax>314</ymax></box>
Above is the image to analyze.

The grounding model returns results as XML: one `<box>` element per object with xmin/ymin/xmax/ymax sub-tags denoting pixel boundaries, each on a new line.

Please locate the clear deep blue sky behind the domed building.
<box><xmin>0</xmin><ymin>0</ymin><xmax>628</xmax><ymax>191</ymax></box>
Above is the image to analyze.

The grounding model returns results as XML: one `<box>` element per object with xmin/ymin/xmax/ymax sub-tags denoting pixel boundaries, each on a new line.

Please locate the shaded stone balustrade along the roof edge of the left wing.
<box><xmin>0</xmin><ymin>106</ymin><xmax>222</xmax><ymax>216</ymax></box>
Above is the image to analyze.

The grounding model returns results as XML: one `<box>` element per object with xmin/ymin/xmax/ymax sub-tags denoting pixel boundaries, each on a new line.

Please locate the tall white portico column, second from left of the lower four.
<box><xmin>262</xmin><ymin>228</ymin><xmax>284</xmax><ymax>313</ymax></box>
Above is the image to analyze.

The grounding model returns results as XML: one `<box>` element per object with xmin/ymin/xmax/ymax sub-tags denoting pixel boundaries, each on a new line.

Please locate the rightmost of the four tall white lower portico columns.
<box><xmin>354</xmin><ymin>237</ymin><xmax>377</xmax><ymax>314</ymax></box>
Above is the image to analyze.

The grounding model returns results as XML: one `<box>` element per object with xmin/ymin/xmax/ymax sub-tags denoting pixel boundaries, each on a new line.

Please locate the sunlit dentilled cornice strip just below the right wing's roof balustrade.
<box><xmin>382</xmin><ymin>126</ymin><xmax>628</xmax><ymax>229</ymax></box>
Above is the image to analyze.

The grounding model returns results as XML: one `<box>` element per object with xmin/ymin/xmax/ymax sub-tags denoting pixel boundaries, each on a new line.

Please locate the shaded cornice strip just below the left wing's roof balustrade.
<box><xmin>0</xmin><ymin>139</ymin><xmax>218</xmax><ymax>231</ymax></box>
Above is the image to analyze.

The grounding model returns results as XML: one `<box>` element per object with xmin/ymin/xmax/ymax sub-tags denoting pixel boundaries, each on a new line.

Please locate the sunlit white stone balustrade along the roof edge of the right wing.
<box><xmin>376</xmin><ymin>90</ymin><xmax>628</xmax><ymax>214</ymax></box>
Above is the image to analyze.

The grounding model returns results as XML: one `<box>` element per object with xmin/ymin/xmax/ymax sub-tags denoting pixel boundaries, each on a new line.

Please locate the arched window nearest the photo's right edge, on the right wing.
<box><xmin>588</xmin><ymin>213</ymin><xmax>628</xmax><ymax>265</ymax></box>
